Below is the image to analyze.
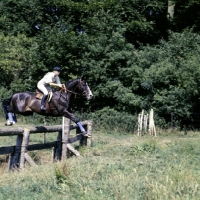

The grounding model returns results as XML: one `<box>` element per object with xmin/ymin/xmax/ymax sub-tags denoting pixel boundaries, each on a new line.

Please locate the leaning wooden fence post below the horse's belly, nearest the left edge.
<box><xmin>19</xmin><ymin>128</ymin><xmax>30</xmax><ymax>169</ymax></box>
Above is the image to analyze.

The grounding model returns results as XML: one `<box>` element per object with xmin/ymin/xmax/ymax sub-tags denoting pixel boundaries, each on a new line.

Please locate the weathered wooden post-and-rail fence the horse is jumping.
<box><xmin>0</xmin><ymin>117</ymin><xmax>92</xmax><ymax>171</ymax></box>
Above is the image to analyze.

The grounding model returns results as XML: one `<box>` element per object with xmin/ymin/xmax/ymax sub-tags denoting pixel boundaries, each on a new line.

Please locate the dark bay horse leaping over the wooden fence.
<box><xmin>2</xmin><ymin>77</ymin><xmax>93</xmax><ymax>136</ymax></box>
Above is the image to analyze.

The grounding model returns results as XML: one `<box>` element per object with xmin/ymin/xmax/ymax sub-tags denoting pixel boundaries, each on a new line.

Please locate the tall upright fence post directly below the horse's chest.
<box><xmin>61</xmin><ymin>117</ymin><xmax>70</xmax><ymax>160</ymax></box>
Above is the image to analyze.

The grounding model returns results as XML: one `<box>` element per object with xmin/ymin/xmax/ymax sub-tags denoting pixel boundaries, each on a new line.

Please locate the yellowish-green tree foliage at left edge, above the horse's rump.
<box><xmin>0</xmin><ymin>34</ymin><xmax>32</xmax><ymax>92</ymax></box>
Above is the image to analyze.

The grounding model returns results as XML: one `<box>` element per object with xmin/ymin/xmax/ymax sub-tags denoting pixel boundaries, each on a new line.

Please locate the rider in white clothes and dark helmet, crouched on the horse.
<box><xmin>37</xmin><ymin>66</ymin><xmax>62</xmax><ymax>110</ymax></box>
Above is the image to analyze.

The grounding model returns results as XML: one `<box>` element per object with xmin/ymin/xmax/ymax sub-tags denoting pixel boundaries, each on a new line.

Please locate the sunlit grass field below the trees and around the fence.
<box><xmin>0</xmin><ymin>121</ymin><xmax>200</xmax><ymax>200</ymax></box>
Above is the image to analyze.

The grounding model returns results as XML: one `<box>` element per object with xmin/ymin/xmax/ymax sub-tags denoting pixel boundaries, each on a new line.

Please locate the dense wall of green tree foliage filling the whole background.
<box><xmin>0</xmin><ymin>0</ymin><xmax>200</xmax><ymax>122</ymax></box>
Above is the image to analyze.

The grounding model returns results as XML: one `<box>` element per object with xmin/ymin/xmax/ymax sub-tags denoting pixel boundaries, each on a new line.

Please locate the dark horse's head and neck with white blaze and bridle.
<box><xmin>66</xmin><ymin>77</ymin><xmax>93</xmax><ymax>100</ymax></box>
